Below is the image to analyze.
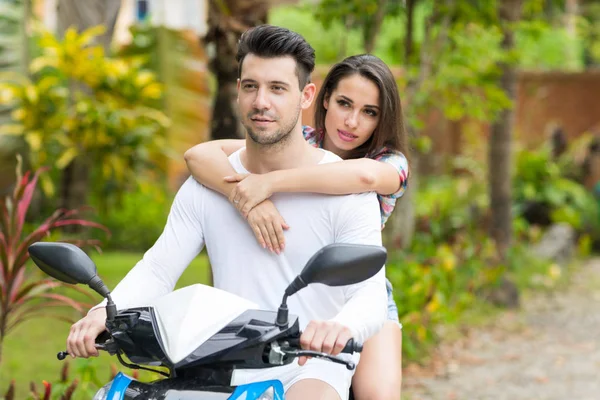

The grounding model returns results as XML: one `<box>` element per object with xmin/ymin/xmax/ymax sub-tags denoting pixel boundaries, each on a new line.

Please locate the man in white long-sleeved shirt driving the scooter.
<box><xmin>67</xmin><ymin>25</ymin><xmax>387</xmax><ymax>400</ymax></box>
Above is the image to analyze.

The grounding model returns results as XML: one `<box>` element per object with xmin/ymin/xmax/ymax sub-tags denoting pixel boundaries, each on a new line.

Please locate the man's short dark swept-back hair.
<box><xmin>236</xmin><ymin>25</ymin><xmax>315</xmax><ymax>90</ymax></box>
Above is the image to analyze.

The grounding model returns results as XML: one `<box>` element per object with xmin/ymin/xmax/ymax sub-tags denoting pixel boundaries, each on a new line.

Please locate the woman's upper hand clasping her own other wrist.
<box><xmin>224</xmin><ymin>174</ymin><xmax>279</xmax><ymax>219</ymax></box>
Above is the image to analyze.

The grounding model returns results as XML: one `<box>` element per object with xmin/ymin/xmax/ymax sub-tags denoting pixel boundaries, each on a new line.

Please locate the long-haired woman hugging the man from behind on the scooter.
<box><xmin>185</xmin><ymin>55</ymin><xmax>408</xmax><ymax>400</ymax></box>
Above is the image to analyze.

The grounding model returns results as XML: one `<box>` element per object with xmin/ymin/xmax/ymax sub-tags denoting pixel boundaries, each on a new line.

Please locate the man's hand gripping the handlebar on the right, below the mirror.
<box><xmin>298</xmin><ymin>321</ymin><xmax>352</xmax><ymax>365</ymax></box>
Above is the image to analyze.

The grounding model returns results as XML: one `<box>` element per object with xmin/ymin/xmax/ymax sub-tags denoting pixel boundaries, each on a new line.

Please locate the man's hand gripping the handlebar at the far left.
<box><xmin>67</xmin><ymin>307</ymin><xmax>106</xmax><ymax>358</ymax></box>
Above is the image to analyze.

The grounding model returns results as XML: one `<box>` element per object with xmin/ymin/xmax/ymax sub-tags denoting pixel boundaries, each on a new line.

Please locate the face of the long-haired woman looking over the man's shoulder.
<box><xmin>323</xmin><ymin>74</ymin><xmax>381</xmax><ymax>158</ymax></box>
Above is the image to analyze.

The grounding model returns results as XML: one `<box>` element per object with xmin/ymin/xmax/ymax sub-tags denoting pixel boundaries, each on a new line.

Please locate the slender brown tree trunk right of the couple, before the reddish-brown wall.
<box><xmin>489</xmin><ymin>0</ymin><xmax>522</xmax><ymax>260</ymax></box>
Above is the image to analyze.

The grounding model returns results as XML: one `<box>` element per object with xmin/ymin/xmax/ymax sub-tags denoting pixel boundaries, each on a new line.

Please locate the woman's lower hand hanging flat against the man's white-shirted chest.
<box><xmin>247</xmin><ymin>200</ymin><xmax>289</xmax><ymax>254</ymax></box>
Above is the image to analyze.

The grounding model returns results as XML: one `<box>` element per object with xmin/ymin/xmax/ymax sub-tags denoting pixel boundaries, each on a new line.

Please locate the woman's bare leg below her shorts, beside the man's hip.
<box><xmin>352</xmin><ymin>321</ymin><xmax>402</xmax><ymax>400</ymax></box>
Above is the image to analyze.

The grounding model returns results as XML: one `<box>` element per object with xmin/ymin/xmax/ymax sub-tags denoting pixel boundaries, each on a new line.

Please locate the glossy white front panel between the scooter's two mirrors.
<box><xmin>149</xmin><ymin>284</ymin><xmax>259</xmax><ymax>364</ymax></box>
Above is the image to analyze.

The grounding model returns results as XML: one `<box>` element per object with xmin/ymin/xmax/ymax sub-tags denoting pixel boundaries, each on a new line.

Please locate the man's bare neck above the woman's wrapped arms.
<box><xmin>240</xmin><ymin>126</ymin><xmax>323</xmax><ymax>174</ymax></box>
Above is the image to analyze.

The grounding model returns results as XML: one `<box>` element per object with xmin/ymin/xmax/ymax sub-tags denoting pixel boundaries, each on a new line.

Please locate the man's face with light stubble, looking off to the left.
<box><xmin>238</xmin><ymin>54</ymin><xmax>304</xmax><ymax>145</ymax></box>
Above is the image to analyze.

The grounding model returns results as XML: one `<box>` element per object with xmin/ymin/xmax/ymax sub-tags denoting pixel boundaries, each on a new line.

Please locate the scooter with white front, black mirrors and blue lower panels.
<box><xmin>28</xmin><ymin>242</ymin><xmax>387</xmax><ymax>400</ymax></box>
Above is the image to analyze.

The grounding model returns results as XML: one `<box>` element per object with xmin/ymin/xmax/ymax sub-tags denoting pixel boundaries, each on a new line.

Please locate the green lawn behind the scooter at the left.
<box><xmin>0</xmin><ymin>252</ymin><xmax>210</xmax><ymax>399</ymax></box>
